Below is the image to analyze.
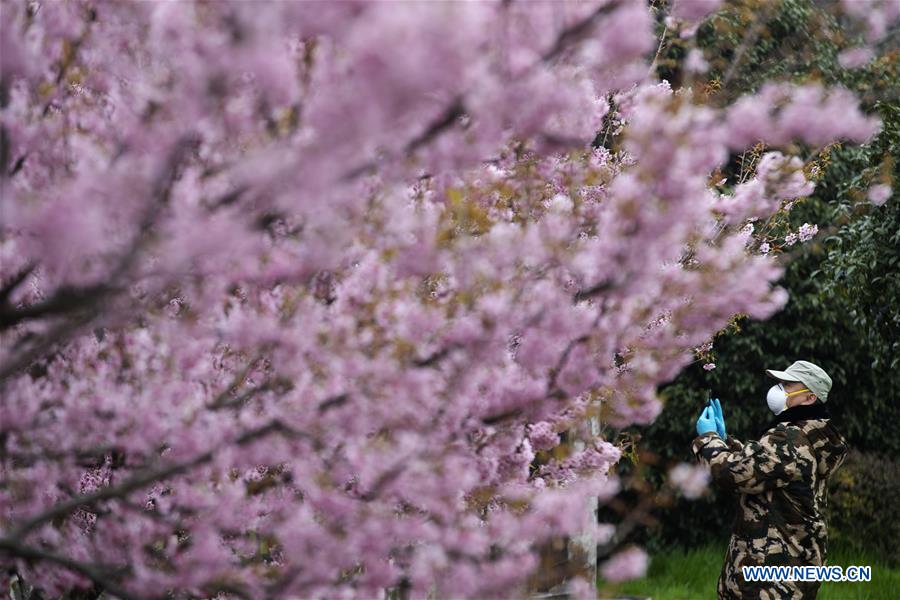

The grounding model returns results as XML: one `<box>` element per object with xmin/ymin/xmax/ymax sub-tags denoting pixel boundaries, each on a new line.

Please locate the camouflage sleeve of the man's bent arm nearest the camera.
<box><xmin>691</xmin><ymin>424</ymin><xmax>815</xmax><ymax>494</ymax></box>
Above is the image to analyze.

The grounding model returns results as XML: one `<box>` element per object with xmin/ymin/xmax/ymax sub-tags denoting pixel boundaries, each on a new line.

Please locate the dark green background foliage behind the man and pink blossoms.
<box><xmin>640</xmin><ymin>0</ymin><xmax>900</xmax><ymax>549</ymax></box>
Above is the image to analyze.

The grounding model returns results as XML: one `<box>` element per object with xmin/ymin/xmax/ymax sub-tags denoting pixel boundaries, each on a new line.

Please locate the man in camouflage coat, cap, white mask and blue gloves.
<box><xmin>691</xmin><ymin>360</ymin><xmax>848</xmax><ymax>600</ymax></box>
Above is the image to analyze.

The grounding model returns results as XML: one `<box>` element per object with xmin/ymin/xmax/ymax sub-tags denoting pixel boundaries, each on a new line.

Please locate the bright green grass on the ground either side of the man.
<box><xmin>599</xmin><ymin>544</ymin><xmax>900</xmax><ymax>600</ymax></box>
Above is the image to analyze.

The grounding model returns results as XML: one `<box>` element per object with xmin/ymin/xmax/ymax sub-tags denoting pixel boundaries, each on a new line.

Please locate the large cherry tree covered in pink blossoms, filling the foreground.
<box><xmin>0</xmin><ymin>0</ymin><xmax>878</xmax><ymax>598</ymax></box>
